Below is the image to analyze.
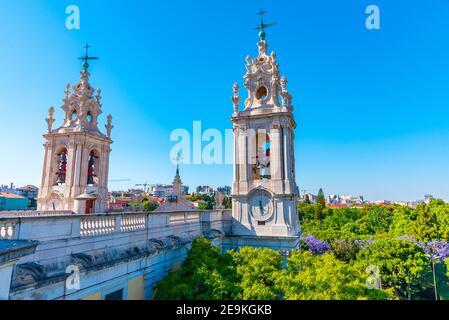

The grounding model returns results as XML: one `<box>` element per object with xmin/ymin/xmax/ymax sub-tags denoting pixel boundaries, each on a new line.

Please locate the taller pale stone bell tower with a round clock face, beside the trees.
<box><xmin>231</xmin><ymin>12</ymin><xmax>300</xmax><ymax>249</ymax></box>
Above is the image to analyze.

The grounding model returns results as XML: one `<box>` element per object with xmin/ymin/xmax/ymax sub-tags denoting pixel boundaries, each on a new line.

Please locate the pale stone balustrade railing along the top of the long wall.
<box><xmin>0</xmin><ymin>211</ymin><xmax>228</xmax><ymax>241</ymax></box>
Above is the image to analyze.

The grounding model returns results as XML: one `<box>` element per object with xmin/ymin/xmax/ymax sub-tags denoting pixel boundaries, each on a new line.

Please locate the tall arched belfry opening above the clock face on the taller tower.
<box><xmin>253</xmin><ymin>133</ymin><xmax>271</xmax><ymax>180</ymax></box>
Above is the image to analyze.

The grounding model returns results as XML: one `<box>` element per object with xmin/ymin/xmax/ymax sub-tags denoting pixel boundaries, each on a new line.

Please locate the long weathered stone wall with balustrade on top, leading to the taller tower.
<box><xmin>0</xmin><ymin>210</ymin><xmax>232</xmax><ymax>300</ymax></box>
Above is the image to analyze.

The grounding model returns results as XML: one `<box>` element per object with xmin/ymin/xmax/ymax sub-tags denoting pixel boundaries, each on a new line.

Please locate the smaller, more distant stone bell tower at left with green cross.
<box><xmin>38</xmin><ymin>45</ymin><xmax>113</xmax><ymax>214</ymax></box>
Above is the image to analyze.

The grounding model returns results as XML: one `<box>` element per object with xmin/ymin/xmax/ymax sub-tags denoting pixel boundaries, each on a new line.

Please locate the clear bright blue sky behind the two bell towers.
<box><xmin>0</xmin><ymin>0</ymin><xmax>449</xmax><ymax>200</ymax></box>
